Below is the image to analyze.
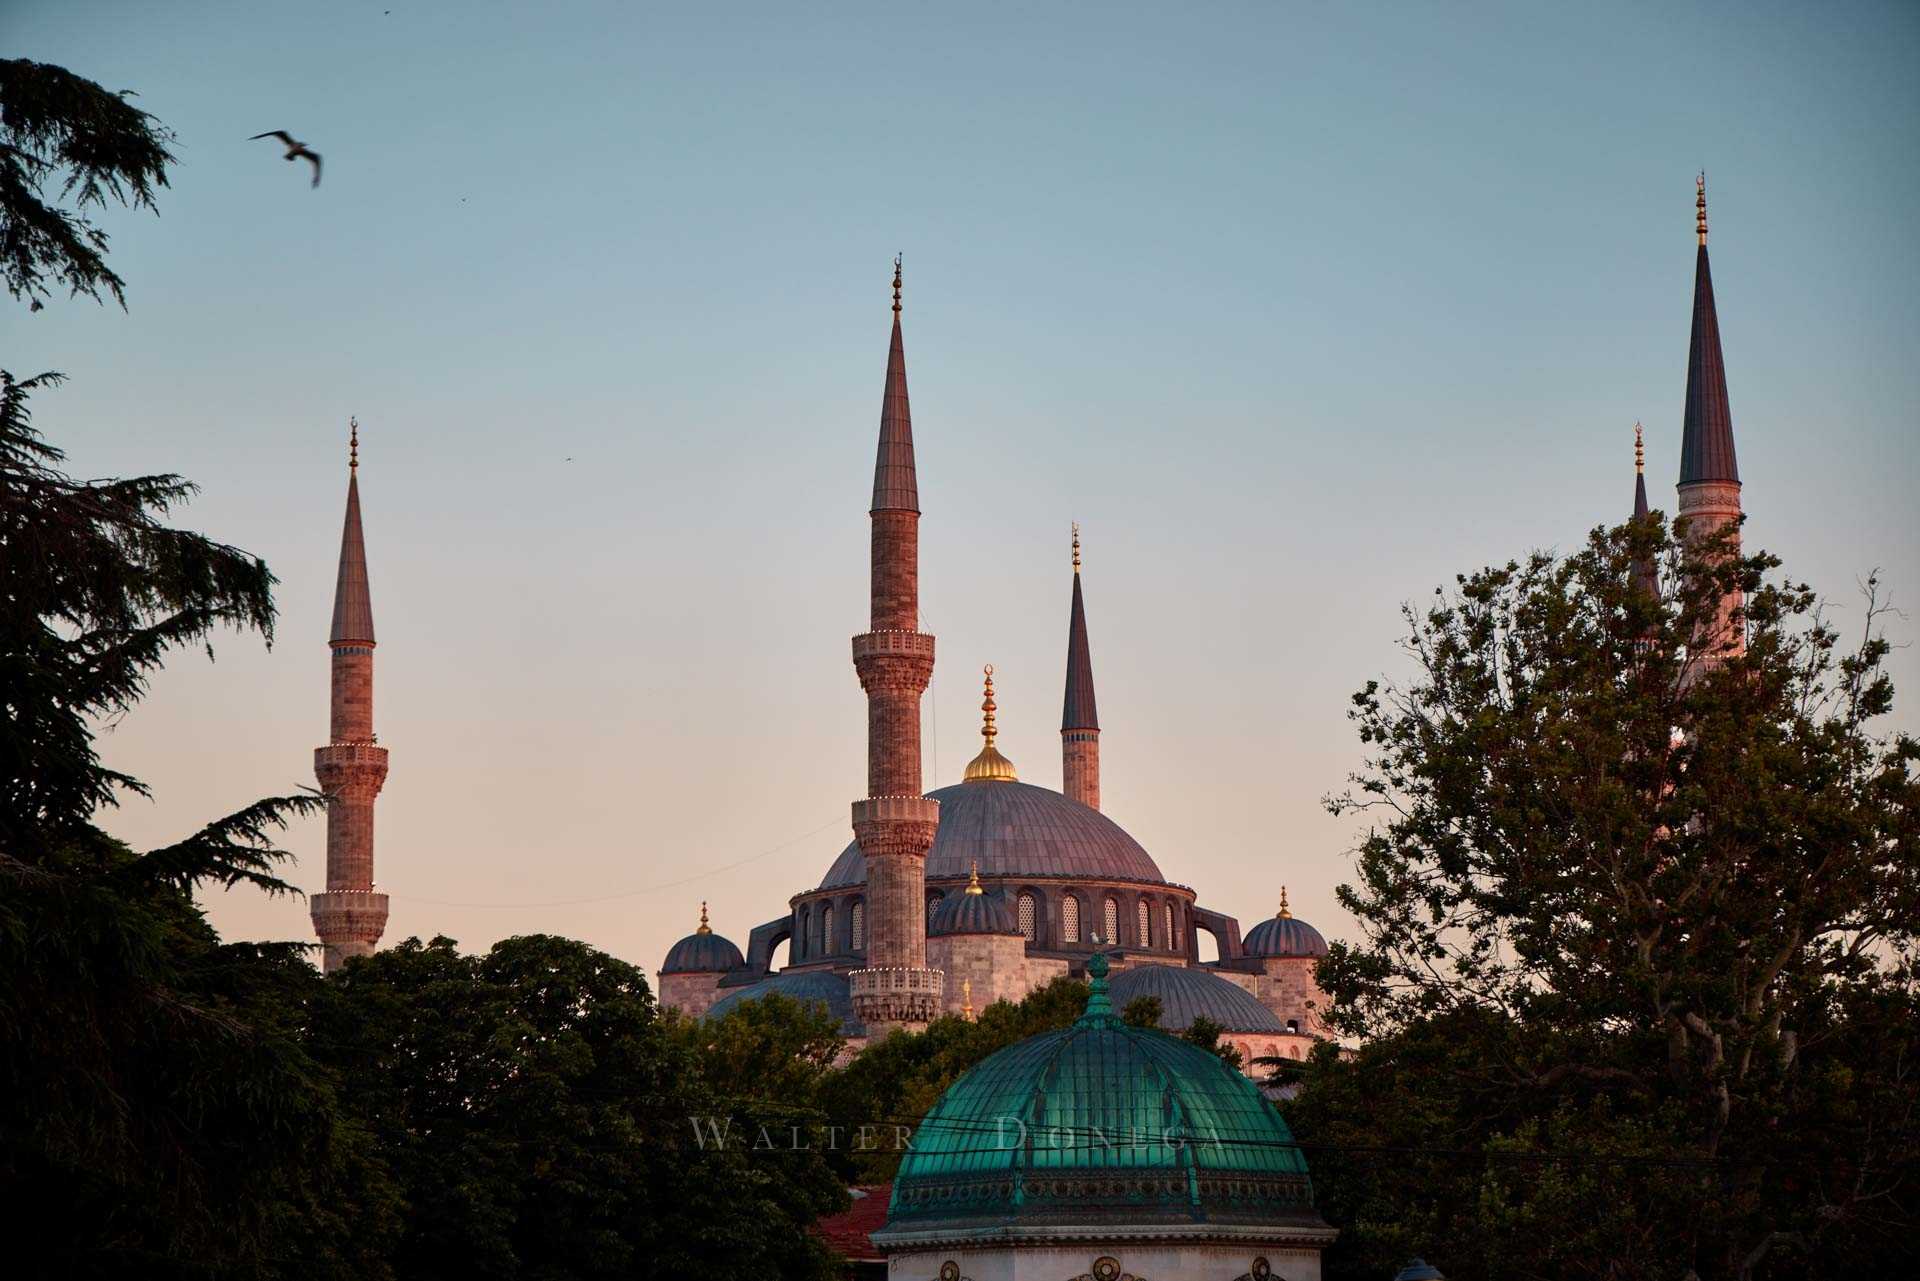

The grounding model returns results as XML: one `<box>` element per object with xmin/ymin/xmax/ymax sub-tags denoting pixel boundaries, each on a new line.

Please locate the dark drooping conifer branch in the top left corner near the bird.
<box><xmin>0</xmin><ymin>58</ymin><xmax>173</xmax><ymax>311</ymax></box>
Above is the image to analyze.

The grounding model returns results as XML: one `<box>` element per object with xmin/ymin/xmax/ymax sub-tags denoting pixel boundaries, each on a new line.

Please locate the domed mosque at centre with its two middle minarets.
<box><xmin>659</xmin><ymin>253</ymin><xmax>1327</xmax><ymax>1070</ymax></box>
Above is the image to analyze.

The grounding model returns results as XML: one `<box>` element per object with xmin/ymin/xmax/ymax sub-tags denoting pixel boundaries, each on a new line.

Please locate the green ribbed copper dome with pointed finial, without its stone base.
<box><xmin>883</xmin><ymin>953</ymin><xmax>1325</xmax><ymax>1237</ymax></box>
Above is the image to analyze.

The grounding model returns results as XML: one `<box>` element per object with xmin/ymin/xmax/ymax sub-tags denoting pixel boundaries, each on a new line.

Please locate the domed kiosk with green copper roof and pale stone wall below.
<box><xmin>874</xmin><ymin>953</ymin><xmax>1334</xmax><ymax>1281</ymax></box>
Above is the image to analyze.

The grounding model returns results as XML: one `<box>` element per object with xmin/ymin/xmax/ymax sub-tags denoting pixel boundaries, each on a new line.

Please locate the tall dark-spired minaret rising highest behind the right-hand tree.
<box><xmin>1680</xmin><ymin>173</ymin><xmax>1747</xmax><ymax>657</ymax></box>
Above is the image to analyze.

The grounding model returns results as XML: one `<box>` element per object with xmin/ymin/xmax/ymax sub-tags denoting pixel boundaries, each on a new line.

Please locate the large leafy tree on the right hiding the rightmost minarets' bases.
<box><xmin>1288</xmin><ymin>517</ymin><xmax>1920</xmax><ymax>1277</ymax></box>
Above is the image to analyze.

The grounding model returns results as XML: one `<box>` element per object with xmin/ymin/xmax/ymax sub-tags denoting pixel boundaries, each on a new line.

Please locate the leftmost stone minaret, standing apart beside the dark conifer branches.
<box><xmin>313</xmin><ymin>423</ymin><xmax>386</xmax><ymax>972</ymax></box>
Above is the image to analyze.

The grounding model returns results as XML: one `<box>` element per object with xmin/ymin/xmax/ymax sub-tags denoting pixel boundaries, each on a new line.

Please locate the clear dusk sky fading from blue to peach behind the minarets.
<box><xmin>15</xmin><ymin>0</ymin><xmax>1920</xmax><ymax>972</ymax></box>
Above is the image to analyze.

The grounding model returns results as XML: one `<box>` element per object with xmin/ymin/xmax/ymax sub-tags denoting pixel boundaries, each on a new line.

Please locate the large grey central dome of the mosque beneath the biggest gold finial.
<box><xmin>820</xmin><ymin>780</ymin><xmax>1165</xmax><ymax>889</ymax></box>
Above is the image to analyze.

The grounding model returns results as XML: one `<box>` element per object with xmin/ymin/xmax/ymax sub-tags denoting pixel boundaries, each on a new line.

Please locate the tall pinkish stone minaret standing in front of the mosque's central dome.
<box><xmin>849</xmin><ymin>257</ymin><xmax>945</xmax><ymax>1037</ymax></box>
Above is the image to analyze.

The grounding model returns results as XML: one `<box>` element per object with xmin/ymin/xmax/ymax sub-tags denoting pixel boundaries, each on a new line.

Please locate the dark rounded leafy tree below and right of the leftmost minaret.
<box><xmin>309</xmin><ymin>935</ymin><xmax>845</xmax><ymax>1281</ymax></box>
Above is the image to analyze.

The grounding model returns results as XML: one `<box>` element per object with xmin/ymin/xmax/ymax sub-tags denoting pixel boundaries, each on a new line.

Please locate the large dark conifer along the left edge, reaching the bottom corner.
<box><xmin>0</xmin><ymin>364</ymin><xmax>393</xmax><ymax>1277</ymax></box>
